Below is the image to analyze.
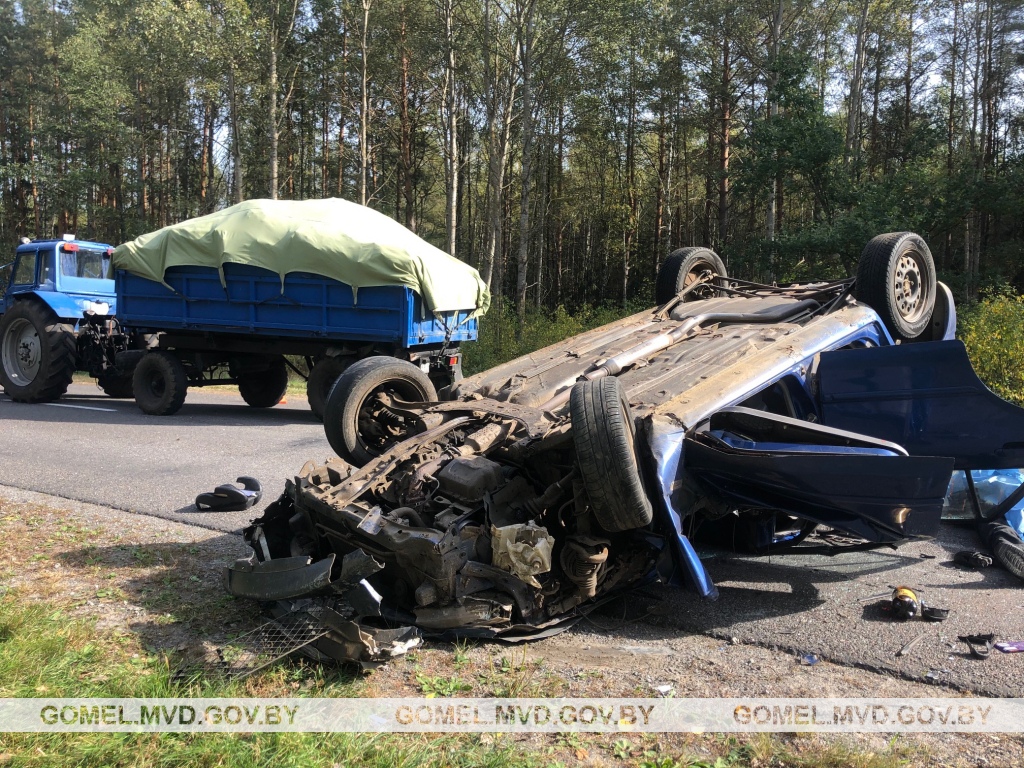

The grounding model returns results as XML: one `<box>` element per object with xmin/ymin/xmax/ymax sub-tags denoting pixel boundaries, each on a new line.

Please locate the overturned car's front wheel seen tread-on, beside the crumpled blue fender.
<box><xmin>569</xmin><ymin>378</ymin><xmax>654</xmax><ymax>532</ymax></box>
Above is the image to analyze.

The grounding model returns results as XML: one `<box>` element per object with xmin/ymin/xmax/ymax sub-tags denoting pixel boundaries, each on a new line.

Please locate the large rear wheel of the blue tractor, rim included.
<box><xmin>0</xmin><ymin>299</ymin><xmax>75</xmax><ymax>402</ymax></box>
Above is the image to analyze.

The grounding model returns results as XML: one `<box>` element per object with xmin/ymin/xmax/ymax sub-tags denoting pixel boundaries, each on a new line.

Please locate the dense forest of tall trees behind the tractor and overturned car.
<box><xmin>0</xmin><ymin>0</ymin><xmax>1024</xmax><ymax>317</ymax></box>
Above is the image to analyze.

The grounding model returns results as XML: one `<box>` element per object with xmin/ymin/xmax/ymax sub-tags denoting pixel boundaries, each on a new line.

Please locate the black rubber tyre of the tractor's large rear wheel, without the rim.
<box><xmin>0</xmin><ymin>299</ymin><xmax>76</xmax><ymax>402</ymax></box>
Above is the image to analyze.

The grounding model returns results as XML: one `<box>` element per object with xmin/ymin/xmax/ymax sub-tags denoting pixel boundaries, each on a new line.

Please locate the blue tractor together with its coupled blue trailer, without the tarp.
<box><xmin>0</xmin><ymin>238</ymin><xmax>477</xmax><ymax>420</ymax></box>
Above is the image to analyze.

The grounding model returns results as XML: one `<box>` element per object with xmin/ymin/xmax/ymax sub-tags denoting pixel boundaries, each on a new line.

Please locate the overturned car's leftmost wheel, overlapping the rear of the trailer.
<box><xmin>324</xmin><ymin>357</ymin><xmax>437</xmax><ymax>467</ymax></box>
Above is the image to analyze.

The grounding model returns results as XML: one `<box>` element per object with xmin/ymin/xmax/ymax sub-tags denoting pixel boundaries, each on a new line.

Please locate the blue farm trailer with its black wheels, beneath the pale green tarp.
<box><xmin>115</xmin><ymin>263</ymin><xmax>477</xmax><ymax>418</ymax></box>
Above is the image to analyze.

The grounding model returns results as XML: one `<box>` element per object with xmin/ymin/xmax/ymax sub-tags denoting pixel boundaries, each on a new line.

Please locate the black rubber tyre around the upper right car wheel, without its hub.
<box><xmin>854</xmin><ymin>232</ymin><xmax>937</xmax><ymax>341</ymax></box>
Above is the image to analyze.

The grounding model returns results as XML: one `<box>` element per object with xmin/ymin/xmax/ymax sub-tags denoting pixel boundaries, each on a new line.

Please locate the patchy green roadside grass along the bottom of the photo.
<box><xmin>0</xmin><ymin>591</ymin><xmax>929</xmax><ymax>768</ymax></box>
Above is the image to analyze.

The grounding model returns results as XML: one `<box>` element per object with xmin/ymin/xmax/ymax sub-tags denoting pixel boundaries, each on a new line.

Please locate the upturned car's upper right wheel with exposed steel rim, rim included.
<box><xmin>854</xmin><ymin>232</ymin><xmax>937</xmax><ymax>341</ymax></box>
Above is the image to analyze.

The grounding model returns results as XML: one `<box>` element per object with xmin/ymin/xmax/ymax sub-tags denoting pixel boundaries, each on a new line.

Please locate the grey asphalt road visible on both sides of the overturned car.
<box><xmin>0</xmin><ymin>385</ymin><xmax>1024</xmax><ymax>696</ymax></box>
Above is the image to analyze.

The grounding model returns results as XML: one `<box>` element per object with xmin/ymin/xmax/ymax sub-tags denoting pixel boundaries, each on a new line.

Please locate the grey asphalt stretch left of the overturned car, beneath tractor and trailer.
<box><xmin>0</xmin><ymin>384</ymin><xmax>334</xmax><ymax>531</ymax></box>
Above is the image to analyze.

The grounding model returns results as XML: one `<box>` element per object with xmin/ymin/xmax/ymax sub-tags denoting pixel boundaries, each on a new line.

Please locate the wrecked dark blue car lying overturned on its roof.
<box><xmin>227</xmin><ymin>232</ymin><xmax>1024</xmax><ymax>663</ymax></box>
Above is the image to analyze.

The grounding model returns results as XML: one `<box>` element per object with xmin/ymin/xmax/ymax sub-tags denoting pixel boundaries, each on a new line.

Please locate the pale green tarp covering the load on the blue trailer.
<box><xmin>113</xmin><ymin>199</ymin><xmax>490</xmax><ymax>314</ymax></box>
